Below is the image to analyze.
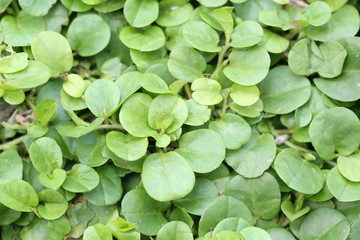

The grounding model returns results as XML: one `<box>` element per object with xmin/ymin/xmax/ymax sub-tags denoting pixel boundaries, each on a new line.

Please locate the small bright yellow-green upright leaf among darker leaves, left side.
<box><xmin>35</xmin><ymin>98</ymin><xmax>58</xmax><ymax>126</ymax></box>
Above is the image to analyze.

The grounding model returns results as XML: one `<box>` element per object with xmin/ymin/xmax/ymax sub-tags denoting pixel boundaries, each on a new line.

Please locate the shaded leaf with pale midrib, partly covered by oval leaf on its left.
<box><xmin>84</xmin><ymin>164</ymin><xmax>123</xmax><ymax>206</ymax></box>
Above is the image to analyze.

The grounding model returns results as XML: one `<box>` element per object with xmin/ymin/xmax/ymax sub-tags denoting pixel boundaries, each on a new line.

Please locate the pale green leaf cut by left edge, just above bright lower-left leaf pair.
<box><xmin>0</xmin><ymin>149</ymin><xmax>23</xmax><ymax>183</ymax></box>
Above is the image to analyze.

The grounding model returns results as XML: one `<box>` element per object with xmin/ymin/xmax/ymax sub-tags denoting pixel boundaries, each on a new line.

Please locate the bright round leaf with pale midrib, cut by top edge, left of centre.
<box><xmin>124</xmin><ymin>0</ymin><xmax>159</xmax><ymax>28</ymax></box>
